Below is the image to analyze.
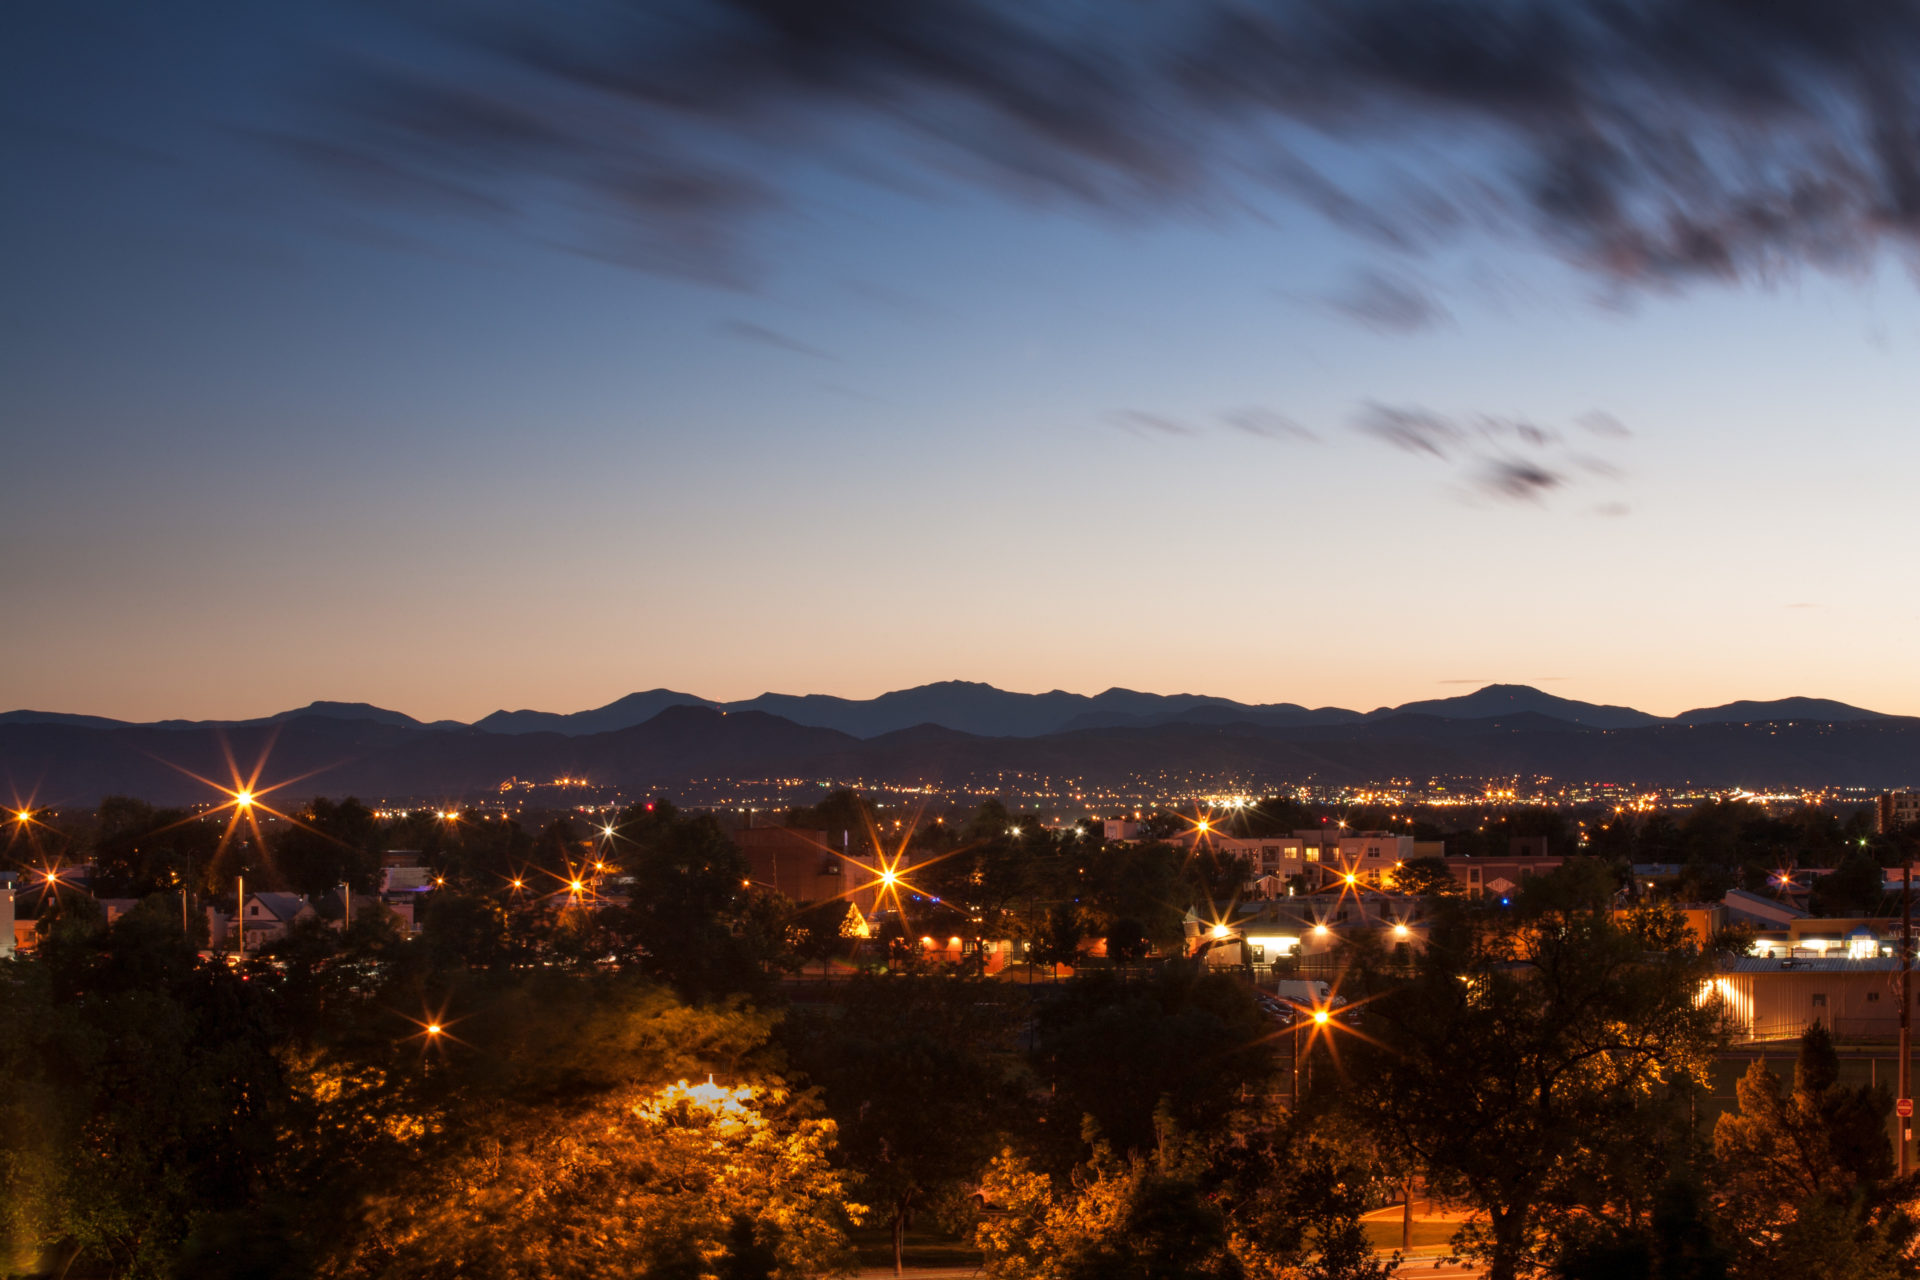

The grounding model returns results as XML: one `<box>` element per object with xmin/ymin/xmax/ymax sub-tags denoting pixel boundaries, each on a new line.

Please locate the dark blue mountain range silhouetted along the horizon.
<box><xmin>0</xmin><ymin>681</ymin><xmax>1920</xmax><ymax>804</ymax></box>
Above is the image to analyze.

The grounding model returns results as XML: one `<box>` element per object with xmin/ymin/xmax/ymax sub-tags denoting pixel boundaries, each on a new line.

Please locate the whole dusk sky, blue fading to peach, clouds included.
<box><xmin>0</xmin><ymin>0</ymin><xmax>1920</xmax><ymax>720</ymax></box>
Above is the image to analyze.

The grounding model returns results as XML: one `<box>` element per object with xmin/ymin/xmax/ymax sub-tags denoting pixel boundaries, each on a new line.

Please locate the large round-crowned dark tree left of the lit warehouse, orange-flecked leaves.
<box><xmin>1352</xmin><ymin>909</ymin><xmax>1716</xmax><ymax>1280</ymax></box>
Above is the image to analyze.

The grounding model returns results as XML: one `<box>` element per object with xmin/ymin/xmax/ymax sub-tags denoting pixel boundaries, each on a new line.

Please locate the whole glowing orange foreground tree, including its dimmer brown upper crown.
<box><xmin>318</xmin><ymin>971</ymin><xmax>860</xmax><ymax>1280</ymax></box>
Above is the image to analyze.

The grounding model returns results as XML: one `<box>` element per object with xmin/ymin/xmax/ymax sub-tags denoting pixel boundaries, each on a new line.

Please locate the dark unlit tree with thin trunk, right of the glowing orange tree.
<box><xmin>791</xmin><ymin>975</ymin><xmax>1020</xmax><ymax>1272</ymax></box>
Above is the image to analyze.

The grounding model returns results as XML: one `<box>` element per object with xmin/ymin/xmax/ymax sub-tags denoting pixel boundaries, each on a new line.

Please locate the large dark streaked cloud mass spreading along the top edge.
<box><xmin>274</xmin><ymin>0</ymin><xmax>1920</xmax><ymax>285</ymax></box>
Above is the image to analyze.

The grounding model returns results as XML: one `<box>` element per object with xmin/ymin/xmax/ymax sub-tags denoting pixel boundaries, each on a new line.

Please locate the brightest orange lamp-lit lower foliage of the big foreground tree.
<box><xmin>323</xmin><ymin>1080</ymin><xmax>856</xmax><ymax>1280</ymax></box>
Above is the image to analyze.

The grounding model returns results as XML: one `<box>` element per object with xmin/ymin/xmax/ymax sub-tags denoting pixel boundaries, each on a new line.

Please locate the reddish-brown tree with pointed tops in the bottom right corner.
<box><xmin>1713</xmin><ymin>1023</ymin><xmax>1916</xmax><ymax>1280</ymax></box>
